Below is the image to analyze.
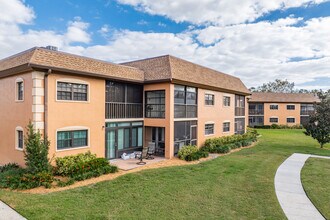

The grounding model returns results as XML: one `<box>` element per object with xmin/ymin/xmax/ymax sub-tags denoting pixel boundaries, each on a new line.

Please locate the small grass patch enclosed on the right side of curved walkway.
<box><xmin>301</xmin><ymin>158</ymin><xmax>330</xmax><ymax>219</ymax></box>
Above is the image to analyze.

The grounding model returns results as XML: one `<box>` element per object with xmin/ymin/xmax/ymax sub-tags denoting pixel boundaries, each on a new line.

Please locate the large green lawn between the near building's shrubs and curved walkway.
<box><xmin>0</xmin><ymin>130</ymin><xmax>330</xmax><ymax>219</ymax></box>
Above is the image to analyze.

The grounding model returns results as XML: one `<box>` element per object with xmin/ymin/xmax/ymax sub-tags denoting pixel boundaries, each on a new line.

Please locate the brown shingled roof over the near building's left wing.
<box><xmin>0</xmin><ymin>47</ymin><xmax>144</xmax><ymax>82</ymax></box>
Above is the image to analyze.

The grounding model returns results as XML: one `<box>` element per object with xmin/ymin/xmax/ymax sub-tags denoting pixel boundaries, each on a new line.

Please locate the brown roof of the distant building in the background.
<box><xmin>249</xmin><ymin>92</ymin><xmax>320</xmax><ymax>103</ymax></box>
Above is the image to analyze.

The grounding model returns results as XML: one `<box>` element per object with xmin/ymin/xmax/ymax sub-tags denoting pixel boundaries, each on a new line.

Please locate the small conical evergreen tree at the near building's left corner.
<box><xmin>24</xmin><ymin>122</ymin><xmax>51</xmax><ymax>173</ymax></box>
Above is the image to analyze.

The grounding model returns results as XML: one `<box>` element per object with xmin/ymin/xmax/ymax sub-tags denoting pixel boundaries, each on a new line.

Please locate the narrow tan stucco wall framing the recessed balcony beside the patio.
<box><xmin>144</xmin><ymin>83</ymin><xmax>174</xmax><ymax>158</ymax></box>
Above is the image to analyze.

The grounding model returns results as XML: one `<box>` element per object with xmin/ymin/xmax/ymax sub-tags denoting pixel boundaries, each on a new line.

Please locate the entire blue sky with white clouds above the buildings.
<box><xmin>0</xmin><ymin>0</ymin><xmax>330</xmax><ymax>89</ymax></box>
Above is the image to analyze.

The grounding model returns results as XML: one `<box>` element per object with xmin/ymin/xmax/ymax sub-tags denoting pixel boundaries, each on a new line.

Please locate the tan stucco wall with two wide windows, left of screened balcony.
<box><xmin>46</xmin><ymin>73</ymin><xmax>105</xmax><ymax>160</ymax></box>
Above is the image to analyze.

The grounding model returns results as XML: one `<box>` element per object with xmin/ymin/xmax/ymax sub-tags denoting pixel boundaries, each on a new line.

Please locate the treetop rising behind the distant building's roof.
<box><xmin>250</xmin><ymin>79</ymin><xmax>294</xmax><ymax>93</ymax></box>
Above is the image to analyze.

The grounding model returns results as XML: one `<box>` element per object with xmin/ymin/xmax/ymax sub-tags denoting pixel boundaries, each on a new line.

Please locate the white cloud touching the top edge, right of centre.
<box><xmin>117</xmin><ymin>0</ymin><xmax>329</xmax><ymax>25</ymax></box>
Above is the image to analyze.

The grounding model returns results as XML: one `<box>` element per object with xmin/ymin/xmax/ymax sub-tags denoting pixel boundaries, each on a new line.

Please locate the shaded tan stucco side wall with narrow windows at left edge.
<box><xmin>0</xmin><ymin>72</ymin><xmax>33</xmax><ymax>165</ymax></box>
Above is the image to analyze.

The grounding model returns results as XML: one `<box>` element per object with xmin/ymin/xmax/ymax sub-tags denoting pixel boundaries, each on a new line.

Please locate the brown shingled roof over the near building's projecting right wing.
<box><xmin>122</xmin><ymin>55</ymin><xmax>250</xmax><ymax>95</ymax></box>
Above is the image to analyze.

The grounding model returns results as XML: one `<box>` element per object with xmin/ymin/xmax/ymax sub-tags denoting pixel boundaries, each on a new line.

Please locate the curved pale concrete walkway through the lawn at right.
<box><xmin>275</xmin><ymin>153</ymin><xmax>330</xmax><ymax>220</ymax></box>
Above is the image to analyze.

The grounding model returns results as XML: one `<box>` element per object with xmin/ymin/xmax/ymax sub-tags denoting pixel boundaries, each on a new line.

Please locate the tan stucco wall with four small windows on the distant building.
<box><xmin>264</xmin><ymin>103</ymin><xmax>300</xmax><ymax>125</ymax></box>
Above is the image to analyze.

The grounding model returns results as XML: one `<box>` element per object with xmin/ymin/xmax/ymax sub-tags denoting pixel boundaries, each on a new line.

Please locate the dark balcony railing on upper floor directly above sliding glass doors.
<box><xmin>105</xmin><ymin>102</ymin><xmax>143</xmax><ymax>119</ymax></box>
